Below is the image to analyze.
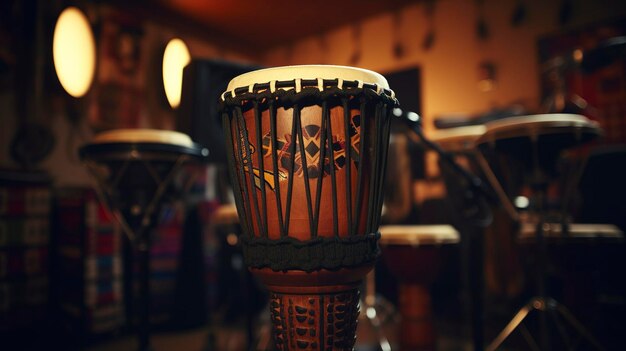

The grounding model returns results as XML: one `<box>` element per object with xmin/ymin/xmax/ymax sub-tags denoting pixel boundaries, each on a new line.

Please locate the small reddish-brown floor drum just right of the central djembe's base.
<box><xmin>380</xmin><ymin>225</ymin><xmax>459</xmax><ymax>350</ymax></box>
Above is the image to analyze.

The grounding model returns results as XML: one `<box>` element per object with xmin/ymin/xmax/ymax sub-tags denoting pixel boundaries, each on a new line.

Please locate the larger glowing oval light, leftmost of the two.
<box><xmin>52</xmin><ymin>7</ymin><xmax>96</xmax><ymax>98</ymax></box>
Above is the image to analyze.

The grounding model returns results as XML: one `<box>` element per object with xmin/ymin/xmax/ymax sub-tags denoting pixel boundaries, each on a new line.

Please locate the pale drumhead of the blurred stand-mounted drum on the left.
<box><xmin>91</xmin><ymin>129</ymin><xmax>194</xmax><ymax>147</ymax></box>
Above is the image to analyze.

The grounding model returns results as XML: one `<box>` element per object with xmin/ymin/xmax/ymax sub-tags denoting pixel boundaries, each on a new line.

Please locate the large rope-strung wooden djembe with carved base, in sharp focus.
<box><xmin>222</xmin><ymin>66</ymin><xmax>397</xmax><ymax>350</ymax></box>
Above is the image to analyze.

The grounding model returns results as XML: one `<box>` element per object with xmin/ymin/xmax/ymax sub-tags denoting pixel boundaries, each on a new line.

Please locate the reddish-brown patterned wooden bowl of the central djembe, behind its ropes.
<box><xmin>230</xmin><ymin>99</ymin><xmax>378</xmax><ymax>241</ymax></box>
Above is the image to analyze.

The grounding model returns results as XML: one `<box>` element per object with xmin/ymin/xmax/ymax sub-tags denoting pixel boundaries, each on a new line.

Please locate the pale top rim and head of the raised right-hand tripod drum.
<box><xmin>475</xmin><ymin>113</ymin><xmax>602</xmax><ymax>145</ymax></box>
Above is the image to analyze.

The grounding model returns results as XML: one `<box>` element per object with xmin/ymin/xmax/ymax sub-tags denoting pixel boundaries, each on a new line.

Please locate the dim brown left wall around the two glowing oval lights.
<box><xmin>0</xmin><ymin>5</ymin><xmax>254</xmax><ymax>186</ymax></box>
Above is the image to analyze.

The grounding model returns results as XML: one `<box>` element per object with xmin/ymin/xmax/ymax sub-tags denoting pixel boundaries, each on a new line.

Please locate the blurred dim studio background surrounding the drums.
<box><xmin>0</xmin><ymin>0</ymin><xmax>626</xmax><ymax>351</ymax></box>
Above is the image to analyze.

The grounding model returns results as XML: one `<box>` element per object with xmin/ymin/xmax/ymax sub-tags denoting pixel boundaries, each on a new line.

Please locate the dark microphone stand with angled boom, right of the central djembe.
<box><xmin>403</xmin><ymin>113</ymin><xmax>498</xmax><ymax>350</ymax></box>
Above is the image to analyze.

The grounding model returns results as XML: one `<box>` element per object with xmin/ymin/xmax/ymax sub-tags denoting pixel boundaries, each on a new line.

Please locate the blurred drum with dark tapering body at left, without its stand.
<box><xmin>80</xmin><ymin>129</ymin><xmax>208</xmax><ymax>238</ymax></box>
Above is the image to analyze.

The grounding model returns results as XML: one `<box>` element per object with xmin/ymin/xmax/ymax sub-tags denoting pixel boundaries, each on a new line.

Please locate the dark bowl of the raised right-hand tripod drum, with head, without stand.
<box><xmin>476</xmin><ymin>114</ymin><xmax>602</xmax><ymax>219</ymax></box>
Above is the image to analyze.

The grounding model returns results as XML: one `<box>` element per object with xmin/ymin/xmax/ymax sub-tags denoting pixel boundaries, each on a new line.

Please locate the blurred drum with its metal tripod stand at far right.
<box><xmin>476</xmin><ymin>113</ymin><xmax>602</xmax><ymax>350</ymax></box>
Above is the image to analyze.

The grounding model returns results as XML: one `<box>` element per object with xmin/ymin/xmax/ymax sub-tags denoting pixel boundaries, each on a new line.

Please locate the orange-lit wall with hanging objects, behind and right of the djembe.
<box><xmin>264</xmin><ymin>0</ymin><xmax>626</xmax><ymax>132</ymax></box>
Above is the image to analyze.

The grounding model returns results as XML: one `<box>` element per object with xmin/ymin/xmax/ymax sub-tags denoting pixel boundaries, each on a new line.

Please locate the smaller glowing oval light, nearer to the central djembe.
<box><xmin>163</xmin><ymin>38</ymin><xmax>191</xmax><ymax>108</ymax></box>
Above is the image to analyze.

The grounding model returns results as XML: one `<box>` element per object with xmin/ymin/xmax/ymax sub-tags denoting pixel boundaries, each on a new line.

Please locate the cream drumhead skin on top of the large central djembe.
<box><xmin>226</xmin><ymin>65</ymin><xmax>389</xmax><ymax>92</ymax></box>
